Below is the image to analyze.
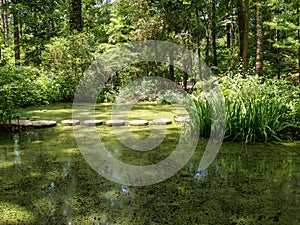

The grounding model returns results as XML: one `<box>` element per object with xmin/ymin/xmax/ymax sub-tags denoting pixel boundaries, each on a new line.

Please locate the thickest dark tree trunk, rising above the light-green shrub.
<box><xmin>69</xmin><ymin>0</ymin><xmax>83</xmax><ymax>32</ymax></box>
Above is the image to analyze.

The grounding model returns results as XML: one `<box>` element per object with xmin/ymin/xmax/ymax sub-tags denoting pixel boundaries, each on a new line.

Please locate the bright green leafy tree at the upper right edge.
<box><xmin>264</xmin><ymin>0</ymin><xmax>300</xmax><ymax>79</ymax></box>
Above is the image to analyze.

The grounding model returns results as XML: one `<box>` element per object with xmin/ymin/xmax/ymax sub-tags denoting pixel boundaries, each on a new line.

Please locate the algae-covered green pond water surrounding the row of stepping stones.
<box><xmin>0</xmin><ymin>104</ymin><xmax>300</xmax><ymax>225</ymax></box>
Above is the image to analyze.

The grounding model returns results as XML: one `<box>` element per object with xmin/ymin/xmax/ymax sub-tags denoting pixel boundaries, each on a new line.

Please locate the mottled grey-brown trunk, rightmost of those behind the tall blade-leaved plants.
<box><xmin>255</xmin><ymin>0</ymin><xmax>263</xmax><ymax>76</ymax></box>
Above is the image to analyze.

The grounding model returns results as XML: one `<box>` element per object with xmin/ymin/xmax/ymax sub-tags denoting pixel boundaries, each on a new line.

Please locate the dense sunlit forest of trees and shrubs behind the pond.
<box><xmin>0</xmin><ymin>0</ymin><xmax>300</xmax><ymax>142</ymax></box>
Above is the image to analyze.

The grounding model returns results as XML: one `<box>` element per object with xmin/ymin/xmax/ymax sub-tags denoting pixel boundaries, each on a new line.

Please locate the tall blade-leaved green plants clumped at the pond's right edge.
<box><xmin>195</xmin><ymin>77</ymin><xmax>300</xmax><ymax>143</ymax></box>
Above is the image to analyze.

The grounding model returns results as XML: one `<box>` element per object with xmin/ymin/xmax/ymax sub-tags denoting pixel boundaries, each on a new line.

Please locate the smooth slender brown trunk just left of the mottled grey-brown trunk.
<box><xmin>243</xmin><ymin>0</ymin><xmax>249</xmax><ymax>75</ymax></box>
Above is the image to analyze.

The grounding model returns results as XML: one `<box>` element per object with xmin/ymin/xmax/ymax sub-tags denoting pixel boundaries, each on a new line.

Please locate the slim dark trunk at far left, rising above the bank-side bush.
<box><xmin>13</xmin><ymin>0</ymin><xmax>21</xmax><ymax>65</ymax></box>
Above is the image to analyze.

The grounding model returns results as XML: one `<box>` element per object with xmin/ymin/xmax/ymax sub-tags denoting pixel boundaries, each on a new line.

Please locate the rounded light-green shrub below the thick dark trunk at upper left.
<box><xmin>42</xmin><ymin>34</ymin><xmax>93</xmax><ymax>100</ymax></box>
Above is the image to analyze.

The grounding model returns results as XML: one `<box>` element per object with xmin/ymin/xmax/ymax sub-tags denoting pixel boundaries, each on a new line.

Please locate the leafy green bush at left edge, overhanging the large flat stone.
<box><xmin>0</xmin><ymin>66</ymin><xmax>61</xmax><ymax>130</ymax></box>
